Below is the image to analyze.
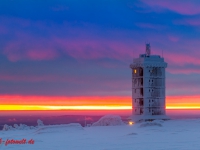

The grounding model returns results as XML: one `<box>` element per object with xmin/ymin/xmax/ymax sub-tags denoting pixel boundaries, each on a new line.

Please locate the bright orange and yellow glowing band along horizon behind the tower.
<box><xmin>0</xmin><ymin>95</ymin><xmax>200</xmax><ymax>110</ymax></box>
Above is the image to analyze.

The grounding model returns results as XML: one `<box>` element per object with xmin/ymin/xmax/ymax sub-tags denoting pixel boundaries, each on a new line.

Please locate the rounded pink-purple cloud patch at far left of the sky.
<box><xmin>4</xmin><ymin>34</ymin><xmax>58</xmax><ymax>61</ymax></box>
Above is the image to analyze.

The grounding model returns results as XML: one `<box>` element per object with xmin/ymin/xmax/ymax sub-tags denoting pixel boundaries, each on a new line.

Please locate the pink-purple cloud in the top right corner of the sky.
<box><xmin>142</xmin><ymin>0</ymin><xmax>200</xmax><ymax>15</ymax></box>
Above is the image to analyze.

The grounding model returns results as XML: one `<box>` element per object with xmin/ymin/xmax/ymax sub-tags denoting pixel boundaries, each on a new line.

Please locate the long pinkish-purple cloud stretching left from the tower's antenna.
<box><xmin>53</xmin><ymin>38</ymin><xmax>141</xmax><ymax>60</ymax></box>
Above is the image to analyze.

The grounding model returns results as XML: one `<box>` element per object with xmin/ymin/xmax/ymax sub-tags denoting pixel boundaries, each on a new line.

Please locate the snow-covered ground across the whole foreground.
<box><xmin>0</xmin><ymin>119</ymin><xmax>200</xmax><ymax>150</ymax></box>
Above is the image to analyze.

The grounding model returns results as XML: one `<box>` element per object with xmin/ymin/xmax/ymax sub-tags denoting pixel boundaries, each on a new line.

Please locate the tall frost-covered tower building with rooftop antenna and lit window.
<box><xmin>130</xmin><ymin>44</ymin><xmax>169</xmax><ymax>121</ymax></box>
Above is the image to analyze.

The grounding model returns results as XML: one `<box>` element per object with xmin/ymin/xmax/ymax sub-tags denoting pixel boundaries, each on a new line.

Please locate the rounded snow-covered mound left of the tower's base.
<box><xmin>92</xmin><ymin>115</ymin><xmax>125</xmax><ymax>126</ymax></box>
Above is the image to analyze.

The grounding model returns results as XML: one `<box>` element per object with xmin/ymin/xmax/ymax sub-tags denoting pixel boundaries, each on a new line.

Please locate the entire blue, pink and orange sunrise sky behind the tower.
<box><xmin>0</xmin><ymin>0</ymin><xmax>200</xmax><ymax>110</ymax></box>
